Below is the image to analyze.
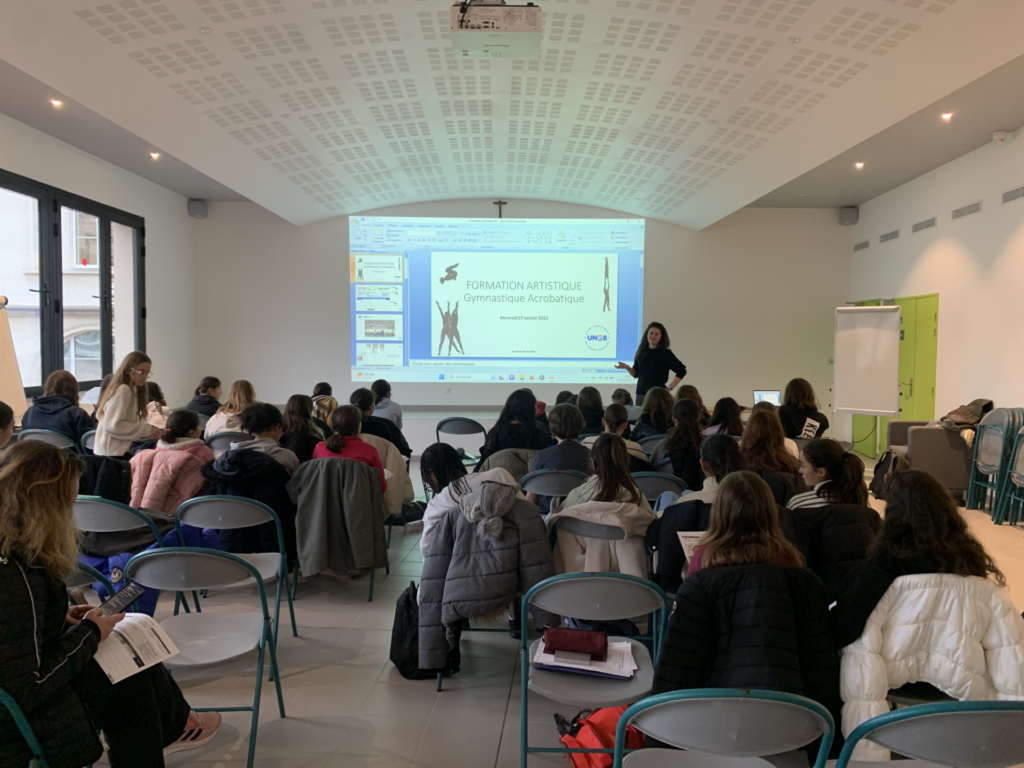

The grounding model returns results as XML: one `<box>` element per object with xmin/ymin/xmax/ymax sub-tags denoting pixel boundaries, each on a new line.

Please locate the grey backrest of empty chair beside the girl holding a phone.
<box><xmin>125</xmin><ymin>547</ymin><xmax>266</xmax><ymax>615</ymax></box>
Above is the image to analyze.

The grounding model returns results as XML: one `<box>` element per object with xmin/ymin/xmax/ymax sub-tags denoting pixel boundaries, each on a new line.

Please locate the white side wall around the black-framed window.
<box><xmin>0</xmin><ymin>115</ymin><xmax>196</xmax><ymax>406</ymax></box>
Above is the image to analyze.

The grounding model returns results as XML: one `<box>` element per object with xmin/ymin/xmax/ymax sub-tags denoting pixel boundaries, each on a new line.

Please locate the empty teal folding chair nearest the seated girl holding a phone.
<box><xmin>125</xmin><ymin>547</ymin><xmax>285</xmax><ymax>768</ymax></box>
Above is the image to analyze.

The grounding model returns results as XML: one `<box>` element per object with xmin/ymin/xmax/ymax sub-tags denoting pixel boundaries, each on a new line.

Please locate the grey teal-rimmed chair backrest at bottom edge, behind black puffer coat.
<box><xmin>614</xmin><ymin>688</ymin><xmax>836</xmax><ymax>768</ymax></box>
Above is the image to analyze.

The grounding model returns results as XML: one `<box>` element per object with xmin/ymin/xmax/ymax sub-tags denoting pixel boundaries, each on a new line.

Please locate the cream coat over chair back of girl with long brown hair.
<box><xmin>548</xmin><ymin>502</ymin><xmax>654</xmax><ymax>579</ymax></box>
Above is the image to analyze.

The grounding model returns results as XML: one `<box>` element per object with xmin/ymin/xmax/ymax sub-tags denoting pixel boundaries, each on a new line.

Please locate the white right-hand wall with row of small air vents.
<box><xmin>846</xmin><ymin>132</ymin><xmax>1024</xmax><ymax>416</ymax></box>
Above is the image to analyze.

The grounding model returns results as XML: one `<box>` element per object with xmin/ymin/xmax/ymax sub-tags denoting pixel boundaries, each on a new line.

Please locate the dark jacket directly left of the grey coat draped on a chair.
<box><xmin>200</xmin><ymin>449</ymin><xmax>297</xmax><ymax>562</ymax></box>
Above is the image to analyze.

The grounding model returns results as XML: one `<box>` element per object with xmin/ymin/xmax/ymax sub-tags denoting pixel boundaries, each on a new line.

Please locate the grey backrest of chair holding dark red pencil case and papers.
<box><xmin>523</xmin><ymin>573</ymin><xmax>669</xmax><ymax>622</ymax></box>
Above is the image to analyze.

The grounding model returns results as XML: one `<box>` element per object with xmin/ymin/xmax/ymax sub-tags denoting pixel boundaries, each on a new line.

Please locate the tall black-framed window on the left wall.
<box><xmin>0</xmin><ymin>170</ymin><xmax>145</xmax><ymax>402</ymax></box>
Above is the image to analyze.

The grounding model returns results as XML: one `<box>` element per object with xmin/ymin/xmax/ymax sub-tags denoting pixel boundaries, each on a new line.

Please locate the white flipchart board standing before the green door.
<box><xmin>833</xmin><ymin>306</ymin><xmax>900</xmax><ymax>417</ymax></box>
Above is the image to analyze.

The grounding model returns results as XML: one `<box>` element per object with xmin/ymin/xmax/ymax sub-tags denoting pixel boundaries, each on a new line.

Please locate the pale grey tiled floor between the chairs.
<box><xmin>97</xmin><ymin>489</ymin><xmax>1024</xmax><ymax>768</ymax></box>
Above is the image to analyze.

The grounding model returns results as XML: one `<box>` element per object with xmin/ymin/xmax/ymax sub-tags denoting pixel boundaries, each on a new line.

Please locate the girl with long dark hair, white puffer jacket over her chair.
<box><xmin>830</xmin><ymin>470</ymin><xmax>1024</xmax><ymax>760</ymax></box>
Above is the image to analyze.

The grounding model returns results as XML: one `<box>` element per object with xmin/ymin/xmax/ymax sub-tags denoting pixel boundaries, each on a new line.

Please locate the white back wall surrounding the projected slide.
<box><xmin>194</xmin><ymin>200</ymin><xmax>849</xmax><ymax>421</ymax></box>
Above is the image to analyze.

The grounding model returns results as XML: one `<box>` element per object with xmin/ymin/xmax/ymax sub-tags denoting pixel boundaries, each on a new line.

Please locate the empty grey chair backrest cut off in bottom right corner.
<box><xmin>836</xmin><ymin>701</ymin><xmax>1024</xmax><ymax>768</ymax></box>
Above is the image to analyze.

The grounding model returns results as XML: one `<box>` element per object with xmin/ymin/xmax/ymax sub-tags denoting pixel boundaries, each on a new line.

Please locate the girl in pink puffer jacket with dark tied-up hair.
<box><xmin>131</xmin><ymin>411</ymin><xmax>213</xmax><ymax>517</ymax></box>
